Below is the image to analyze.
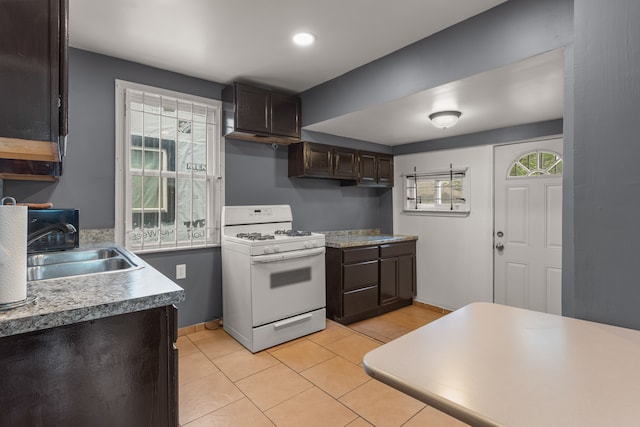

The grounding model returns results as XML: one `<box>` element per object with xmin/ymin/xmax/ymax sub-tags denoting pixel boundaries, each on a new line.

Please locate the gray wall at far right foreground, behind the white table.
<box><xmin>565</xmin><ymin>0</ymin><xmax>640</xmax><ymax>329</ymax></box>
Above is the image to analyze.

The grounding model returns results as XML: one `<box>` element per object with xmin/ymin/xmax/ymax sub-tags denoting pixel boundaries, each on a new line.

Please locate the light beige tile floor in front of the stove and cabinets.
<box><xmin>178</xmin><ymin>305</ymin><xmax>465</xmax><ymax>427</ymax></box>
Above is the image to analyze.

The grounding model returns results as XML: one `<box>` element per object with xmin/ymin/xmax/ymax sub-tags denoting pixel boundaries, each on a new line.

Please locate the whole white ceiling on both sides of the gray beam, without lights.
<box><xmin>69</xmin><ymin>0</ymin><xmax>562</xmax><ymax>145</ymax></box>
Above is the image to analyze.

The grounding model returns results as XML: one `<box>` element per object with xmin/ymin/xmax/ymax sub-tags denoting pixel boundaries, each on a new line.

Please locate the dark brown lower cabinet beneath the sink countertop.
<box><xmin>0</xmin><ymin>306</ymin><xmax>178</xmax><ymax>427</ymax></box>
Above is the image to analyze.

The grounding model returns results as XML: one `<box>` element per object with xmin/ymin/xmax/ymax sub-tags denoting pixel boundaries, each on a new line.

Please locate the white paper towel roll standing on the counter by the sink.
<box><xmin>0</xmin><ymin>205</ymin><xmax>27</xmax><ymax>304</ymax></box>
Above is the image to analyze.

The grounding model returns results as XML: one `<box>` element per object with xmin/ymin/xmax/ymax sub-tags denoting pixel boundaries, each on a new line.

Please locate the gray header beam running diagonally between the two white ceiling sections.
<box><xmin>301</xmin><ymin>0</ymin><xmax>573</xmax><ymax>125</ymax></box>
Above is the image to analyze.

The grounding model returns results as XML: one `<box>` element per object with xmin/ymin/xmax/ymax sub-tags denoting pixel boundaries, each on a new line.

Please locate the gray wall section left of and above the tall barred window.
<box><xmin>4</xmin><ymin>49</ymin><xmax>223</xmax><ymax>228</ymax></box>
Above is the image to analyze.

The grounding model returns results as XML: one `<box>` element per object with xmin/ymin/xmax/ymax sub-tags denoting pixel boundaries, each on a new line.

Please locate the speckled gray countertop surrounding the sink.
<box><xmin>0</xmin><ymin>244</ymin><xmax>184</xmax><ymax>337</ymax></box>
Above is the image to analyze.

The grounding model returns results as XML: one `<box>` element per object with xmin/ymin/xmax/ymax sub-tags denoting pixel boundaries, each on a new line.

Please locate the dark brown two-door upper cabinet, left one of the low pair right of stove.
<box><xmin>289</xmin><ymin>142</ymin><xmax>358</xmax><ymax>181</ymax></box>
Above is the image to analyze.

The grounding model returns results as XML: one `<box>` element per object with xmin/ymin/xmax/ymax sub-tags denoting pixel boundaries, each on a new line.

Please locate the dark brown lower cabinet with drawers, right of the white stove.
<box><xmin>325</xmin><ymin>241</ymin><xmax>416</xmax><ymax>324</ymax></box>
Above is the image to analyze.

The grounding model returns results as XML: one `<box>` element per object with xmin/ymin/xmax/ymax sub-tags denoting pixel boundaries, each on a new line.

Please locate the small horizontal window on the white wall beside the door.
<box><xmin>403</xmin><ymin>167</ymin><xmax>471</xmax><ymax>213</ymax></box>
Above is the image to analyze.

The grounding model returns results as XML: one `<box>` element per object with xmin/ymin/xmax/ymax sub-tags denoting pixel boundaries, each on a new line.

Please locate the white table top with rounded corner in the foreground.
<box><xmin>364</xmin><ymin>303</ymin><xmax>640</xmax><ymax>427</ymax></box>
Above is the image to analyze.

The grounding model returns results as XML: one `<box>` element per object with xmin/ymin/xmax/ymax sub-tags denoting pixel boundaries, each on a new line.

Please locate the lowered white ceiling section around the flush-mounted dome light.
<box><xmin>305</xmin><ymin>50</ymin><xmax>564</xmax><ymax>145</ymax></box>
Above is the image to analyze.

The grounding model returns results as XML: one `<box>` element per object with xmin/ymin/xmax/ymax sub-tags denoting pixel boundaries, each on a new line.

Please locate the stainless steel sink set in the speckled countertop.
<box><xmin>27</xmin><ymin>247</ymin><xmax>141</xmax><ymax>281</ymax></box>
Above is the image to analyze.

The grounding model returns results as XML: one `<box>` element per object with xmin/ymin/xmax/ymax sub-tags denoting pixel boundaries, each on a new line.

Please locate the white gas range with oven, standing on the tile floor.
<box><xmin>222</xmin><ymin>205</ymin><xmax>326</xmax><ymax>353</ymax></box>
